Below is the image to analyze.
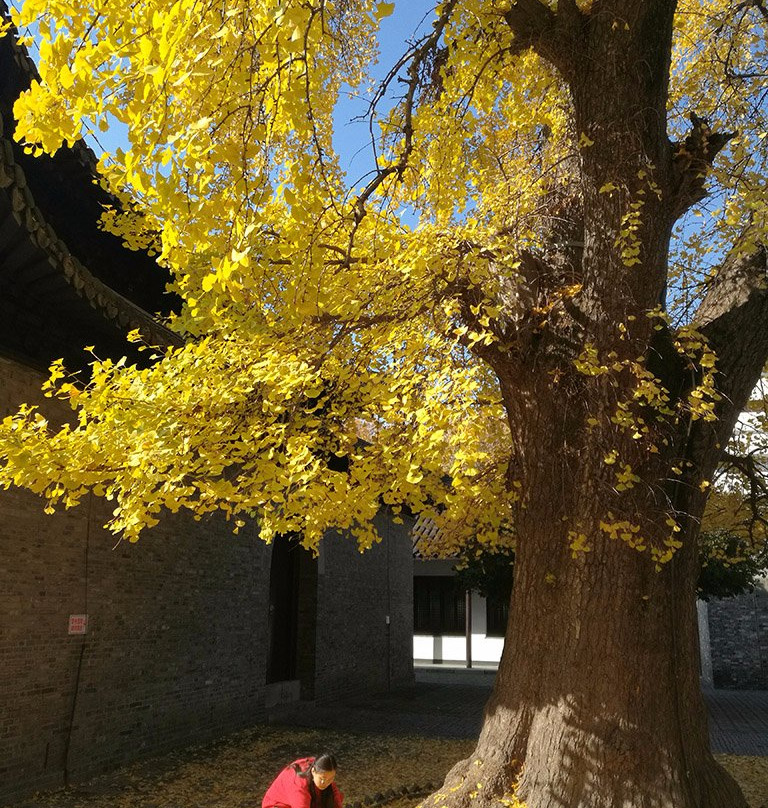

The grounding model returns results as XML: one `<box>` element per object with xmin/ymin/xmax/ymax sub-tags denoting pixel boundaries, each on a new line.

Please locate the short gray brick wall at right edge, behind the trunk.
<box><xmin>707</xmin><ymin>579</ymin><xmax>768</xmax><ymax>690</ymax></box>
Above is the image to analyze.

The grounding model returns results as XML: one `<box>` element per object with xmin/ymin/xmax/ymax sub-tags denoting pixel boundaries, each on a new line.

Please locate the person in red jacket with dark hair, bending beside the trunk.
<box><xmin>261</xmin><ymin>752</ymin><xmax>344</xmax><ymax>808</ymax></box>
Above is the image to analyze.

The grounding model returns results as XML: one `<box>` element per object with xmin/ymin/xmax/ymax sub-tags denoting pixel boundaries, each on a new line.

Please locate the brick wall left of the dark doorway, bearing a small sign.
<box><xmin>0</xmin><ymin>359</ymin><xmax>270</xmax><ymax>804</ymax></box>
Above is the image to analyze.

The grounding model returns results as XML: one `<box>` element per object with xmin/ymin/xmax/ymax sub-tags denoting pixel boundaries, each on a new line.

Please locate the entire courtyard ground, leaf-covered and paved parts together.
<box><xmin>6</xmin><ymin>668</ymin><xmax>768</xmax><ymax>808</ymax></box>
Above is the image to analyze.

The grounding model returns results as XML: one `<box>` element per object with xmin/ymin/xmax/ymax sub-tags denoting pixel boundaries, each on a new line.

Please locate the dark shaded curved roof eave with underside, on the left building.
<box><xmin>0</xmin><ymin>11</ymin><xmax>182</xmax><ymax>367</ymax></box>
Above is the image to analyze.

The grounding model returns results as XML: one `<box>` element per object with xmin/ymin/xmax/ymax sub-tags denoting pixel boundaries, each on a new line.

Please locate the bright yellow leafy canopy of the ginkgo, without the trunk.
<box><xmin>0</xmin><ymin>0</ymin><xmax>768</xmax><ymax>549</ymax></box>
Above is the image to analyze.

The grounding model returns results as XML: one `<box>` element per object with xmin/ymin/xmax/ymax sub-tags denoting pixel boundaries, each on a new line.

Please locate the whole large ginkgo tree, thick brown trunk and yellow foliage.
<box><xmin>0</xmin><ymin>0</ymin><xmax>768</xmax><ymax>808</ymax></box>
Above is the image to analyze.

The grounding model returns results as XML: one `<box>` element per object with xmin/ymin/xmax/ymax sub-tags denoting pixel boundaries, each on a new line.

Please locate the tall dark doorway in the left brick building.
<box><xmin>267</xmin><ymin>536</ymin><xmax>302</xmax><ymax>684</ymax></box>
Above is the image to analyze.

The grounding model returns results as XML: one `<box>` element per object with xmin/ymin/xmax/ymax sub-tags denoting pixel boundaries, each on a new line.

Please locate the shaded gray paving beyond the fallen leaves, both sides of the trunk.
<box><xmin>269</xmin><ymin>669</ymin><xmax>768</xmax><ymax>756</ymax></box>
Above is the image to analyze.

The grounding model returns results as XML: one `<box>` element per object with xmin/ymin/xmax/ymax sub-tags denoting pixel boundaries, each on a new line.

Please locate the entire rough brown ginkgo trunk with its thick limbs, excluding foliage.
<box><xmin>426</xmin><ymin>0</ymin><xmax>768</xmax><ymax>808</ymax></box>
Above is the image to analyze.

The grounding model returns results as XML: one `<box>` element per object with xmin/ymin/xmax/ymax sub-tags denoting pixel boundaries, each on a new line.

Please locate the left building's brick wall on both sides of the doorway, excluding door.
<box><xmin>0</xmin><ymin>358</ymin><xmax>413</xmax><ymax>805</ymax></box>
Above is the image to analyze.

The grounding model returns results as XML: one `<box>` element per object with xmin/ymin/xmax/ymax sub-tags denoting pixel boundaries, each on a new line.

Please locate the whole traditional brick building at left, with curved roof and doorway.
<box><xmin>0</xmin><ymin>20</ymin><xmax>413</xmax><ymax>804</ymax></box>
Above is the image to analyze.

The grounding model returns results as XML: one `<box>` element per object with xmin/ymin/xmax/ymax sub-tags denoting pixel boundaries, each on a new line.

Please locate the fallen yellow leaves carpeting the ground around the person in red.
<box><xmin>7</xmin><ymin>726</ymin><xmax>768</xmax><ymax>808</ymax></box>
